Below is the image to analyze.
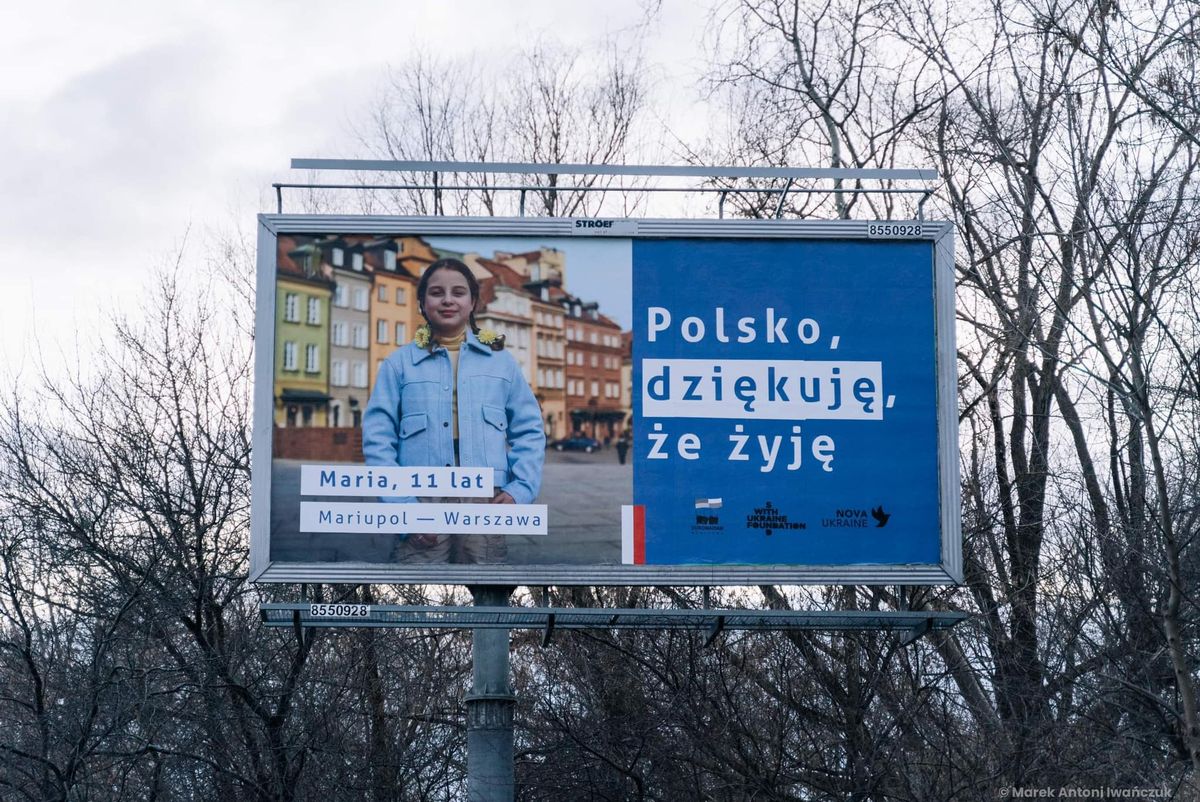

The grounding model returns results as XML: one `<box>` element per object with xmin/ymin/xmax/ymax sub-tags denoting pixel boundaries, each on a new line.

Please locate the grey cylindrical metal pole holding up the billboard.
<box><xmin>466</xmin><ymin>585</ymin><xmax>516</xmax><ymax>802</ymax></box>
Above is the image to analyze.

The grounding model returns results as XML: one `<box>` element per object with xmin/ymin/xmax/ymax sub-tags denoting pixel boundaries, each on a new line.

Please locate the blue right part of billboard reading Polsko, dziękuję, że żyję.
<box><xmin>634</xmin><ymin>239</ymin><xmax>941</xmax><ymax>565</ymax></box>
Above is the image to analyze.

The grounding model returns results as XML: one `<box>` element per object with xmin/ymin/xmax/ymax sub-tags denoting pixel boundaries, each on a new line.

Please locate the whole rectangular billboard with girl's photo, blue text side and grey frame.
<box><xmin>251</xmin><ymin>215</ymin><xmax>961</xmax><ymax>585</ymax></box>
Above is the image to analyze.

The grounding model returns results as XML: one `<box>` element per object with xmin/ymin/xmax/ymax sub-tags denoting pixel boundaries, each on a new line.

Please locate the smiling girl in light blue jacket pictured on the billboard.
<box><xmin>362</xmin><ymin>258</ymin><xmax>546</xmax><ymax>563</ymax></box>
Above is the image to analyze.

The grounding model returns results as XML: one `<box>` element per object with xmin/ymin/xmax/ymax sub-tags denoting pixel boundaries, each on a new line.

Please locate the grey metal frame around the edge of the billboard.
<box><xmin>250</xmin><ymin>216</ymin><xmax>962</xmax><ymax>586</ymax></box>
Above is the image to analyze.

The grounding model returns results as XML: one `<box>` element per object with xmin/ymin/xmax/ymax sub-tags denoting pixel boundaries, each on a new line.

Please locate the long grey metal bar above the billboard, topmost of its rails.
<box><xmin>292</xmin><ymin>158</ymin><xmax>938</xmax><ymax>181</ymax></box>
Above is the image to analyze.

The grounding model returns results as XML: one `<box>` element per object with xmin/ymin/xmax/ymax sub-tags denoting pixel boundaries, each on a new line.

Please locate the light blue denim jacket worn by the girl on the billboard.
<box><xmin>362</xmin><ymin>330</ymin><xmax>546</xmax><ymax>504</ymax></box>
